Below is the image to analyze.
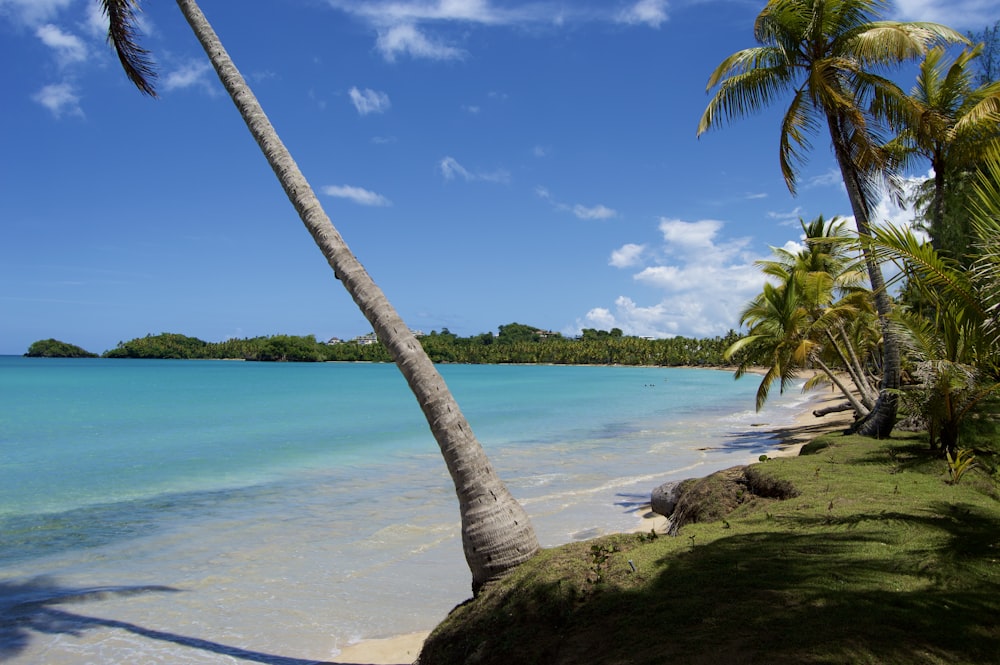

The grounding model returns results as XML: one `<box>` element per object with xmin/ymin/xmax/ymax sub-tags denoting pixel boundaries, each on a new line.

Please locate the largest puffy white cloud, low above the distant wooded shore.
<box><xmin>577</xmin><ymin>218</ymin><xmax>764</xmax><ymax>337</ymax></box>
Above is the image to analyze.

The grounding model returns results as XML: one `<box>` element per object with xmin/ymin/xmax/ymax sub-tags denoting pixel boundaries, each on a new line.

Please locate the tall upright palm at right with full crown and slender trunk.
<box><xmin>698</xmin><ymin>0</ymin><xmax>965</xmax><ymax>437</ymax></box>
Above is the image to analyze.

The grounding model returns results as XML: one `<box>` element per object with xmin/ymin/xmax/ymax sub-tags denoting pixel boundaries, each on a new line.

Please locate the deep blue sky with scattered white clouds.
<box><xmin>0</xmin><ymin>0</ymin><xmax>1000</xmax><ymax>354</ymax></box>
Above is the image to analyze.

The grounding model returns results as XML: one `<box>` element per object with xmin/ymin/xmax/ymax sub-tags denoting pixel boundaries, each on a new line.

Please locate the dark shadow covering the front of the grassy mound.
<box><xmin>421</xmin><ymin>506</ymin><xmax>1000</xmax><ymax>665</ymax></box>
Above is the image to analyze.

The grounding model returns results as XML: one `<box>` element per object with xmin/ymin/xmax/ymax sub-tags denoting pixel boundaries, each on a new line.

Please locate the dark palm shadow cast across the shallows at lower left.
<box><xmin>0</xmin><ymin>577</ymin><xmax>398</xmax><ymax>665</ymax></box>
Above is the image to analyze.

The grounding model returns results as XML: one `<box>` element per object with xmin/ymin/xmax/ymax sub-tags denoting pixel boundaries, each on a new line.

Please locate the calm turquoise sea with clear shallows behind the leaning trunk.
<box><xmin>0</xmin><ymin>357</ymin><xmax>805</xmax><ymax>665</ymax></box>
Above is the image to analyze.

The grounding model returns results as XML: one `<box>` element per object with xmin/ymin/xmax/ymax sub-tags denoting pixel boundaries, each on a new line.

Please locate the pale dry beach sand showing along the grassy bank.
<box><xmin>327</xmin><ymin>392</ymin><xmax>853</xmax><ymax>665</ymax></box>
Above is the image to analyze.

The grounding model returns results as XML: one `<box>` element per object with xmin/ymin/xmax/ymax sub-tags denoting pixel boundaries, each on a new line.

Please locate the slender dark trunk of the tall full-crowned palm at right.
<box><xmin>827</xmin><ymin>115</ymin><xmax>901</xmax><ymax>439</ymax></box>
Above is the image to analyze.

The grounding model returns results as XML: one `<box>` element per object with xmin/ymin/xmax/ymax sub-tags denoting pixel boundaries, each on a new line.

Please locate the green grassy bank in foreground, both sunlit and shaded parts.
<box><xmin>420</xmin><ymin>435</ymin><xmax>1000</xmax><ymax>665</ymax></box>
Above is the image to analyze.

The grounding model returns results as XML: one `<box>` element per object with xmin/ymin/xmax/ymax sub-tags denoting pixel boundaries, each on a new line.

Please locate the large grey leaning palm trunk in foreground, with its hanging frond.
<box><xmin>100</xmin><ymin>0</ymin><xmax>539</xmax><ymax>593</ymax></box>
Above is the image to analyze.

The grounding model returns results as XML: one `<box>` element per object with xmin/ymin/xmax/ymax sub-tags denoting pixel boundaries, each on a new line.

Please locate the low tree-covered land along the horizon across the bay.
<box><xmin>25</xmin><ymin>323</ymin><xmax>752</xmax><ymax>367</ymax></box>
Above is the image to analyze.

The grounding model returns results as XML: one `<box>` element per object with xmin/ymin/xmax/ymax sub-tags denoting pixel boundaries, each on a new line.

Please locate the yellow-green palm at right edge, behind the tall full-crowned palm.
<box><xmin>889</xmin><ymin>44</ymin><xmax>1000</xmax><ymax>261</ymax></box>
